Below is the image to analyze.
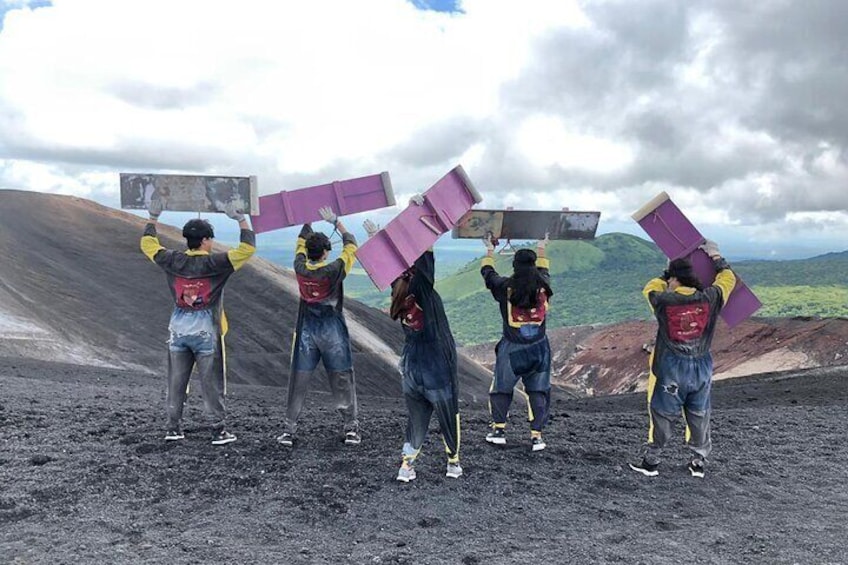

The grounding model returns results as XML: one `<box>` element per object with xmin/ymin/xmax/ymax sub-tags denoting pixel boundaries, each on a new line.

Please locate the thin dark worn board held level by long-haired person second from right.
<box><xmin>451</xmin><ymin>209</ymin><xmax>601</xmax><ymax>240</ymax></box>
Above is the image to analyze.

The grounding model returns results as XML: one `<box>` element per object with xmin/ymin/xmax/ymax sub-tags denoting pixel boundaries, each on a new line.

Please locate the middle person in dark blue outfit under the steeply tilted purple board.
<box><xmin>365</xmin><ymin>195</ymin><xmax>462</xmax><ymax>483</ymax></box>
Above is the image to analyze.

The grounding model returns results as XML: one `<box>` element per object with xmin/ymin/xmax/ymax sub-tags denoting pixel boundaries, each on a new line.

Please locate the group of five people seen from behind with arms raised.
<box><xmin>141</xmin><ymin>195</ymin><xmax>736</xmax><ymax>482</ymax></box>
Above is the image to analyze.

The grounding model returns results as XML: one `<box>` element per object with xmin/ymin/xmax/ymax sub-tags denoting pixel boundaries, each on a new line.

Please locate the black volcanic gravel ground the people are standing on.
<box><xmin>0</xmin><ymin>359</ymin><xmax>848</xmax><ymax>564</ymax></box>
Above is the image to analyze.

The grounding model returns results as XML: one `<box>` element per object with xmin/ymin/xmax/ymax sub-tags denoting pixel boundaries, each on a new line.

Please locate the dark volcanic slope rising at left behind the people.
<box><xmin>0</xmin><ymin>190</ymin><xmax>491</xmax><ymax>401</ymax></box>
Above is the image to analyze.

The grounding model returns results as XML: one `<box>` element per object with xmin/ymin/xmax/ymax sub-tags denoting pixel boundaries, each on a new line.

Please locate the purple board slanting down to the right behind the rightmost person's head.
<box><xmin>633</xmin><ymin>192</ymin><xmax>763</xmax><ymax>328</ymax></box>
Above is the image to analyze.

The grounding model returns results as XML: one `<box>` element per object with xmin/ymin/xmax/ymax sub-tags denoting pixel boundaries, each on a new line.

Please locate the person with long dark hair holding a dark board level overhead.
<box><xmin>480</xmin><ymin>234</ymin><xmax>553</xmax><ymax>451</ymax></box>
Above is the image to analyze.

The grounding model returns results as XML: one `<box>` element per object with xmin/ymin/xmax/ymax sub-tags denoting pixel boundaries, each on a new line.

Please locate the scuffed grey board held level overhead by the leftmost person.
<box><xmin>120</xmin><ymin>173</ymin><xmax>259</xmax><ymax>214</ymax></box>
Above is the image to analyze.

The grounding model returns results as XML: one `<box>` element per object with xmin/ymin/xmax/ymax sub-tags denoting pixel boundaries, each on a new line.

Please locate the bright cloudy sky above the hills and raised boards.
<box><xmin>0</xmin><ymin>0</ymin><xmax>848</xmax><ymax>258</ymax></box>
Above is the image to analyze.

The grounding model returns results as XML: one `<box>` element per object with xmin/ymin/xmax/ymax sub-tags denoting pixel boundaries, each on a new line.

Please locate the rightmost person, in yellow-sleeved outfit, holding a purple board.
<box><xmin>630</xmin><ymin>240</ymin><xmax>736</xmax><ymax>478</ymax></box>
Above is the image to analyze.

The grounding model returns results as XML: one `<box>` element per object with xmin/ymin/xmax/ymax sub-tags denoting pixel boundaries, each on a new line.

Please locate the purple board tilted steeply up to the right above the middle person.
<box><xmin>354</xmin><ymin>165</ymin><xmax>482</xmax><ymax>290</ymax></box>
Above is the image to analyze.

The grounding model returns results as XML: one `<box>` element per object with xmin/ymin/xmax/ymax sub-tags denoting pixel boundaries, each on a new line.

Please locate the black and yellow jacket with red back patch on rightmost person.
<box><xmin>642</xmin><ymin>257</ymin><xmax>736</xmax><ymax>364</ymax></box>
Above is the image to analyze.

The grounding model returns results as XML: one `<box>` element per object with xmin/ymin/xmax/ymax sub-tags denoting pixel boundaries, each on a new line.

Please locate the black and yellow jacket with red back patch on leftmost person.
<box><xmin>141</xmin><ymin>223</ymin><xmax>256</xmax><ymax>335</ymax></box>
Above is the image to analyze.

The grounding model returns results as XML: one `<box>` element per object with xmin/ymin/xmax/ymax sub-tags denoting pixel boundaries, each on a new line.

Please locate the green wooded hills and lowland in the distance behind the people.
<box><xmin>345</xmin><ymin>233</ymin><xmax>848</xmax><ymax>345</ymax></box>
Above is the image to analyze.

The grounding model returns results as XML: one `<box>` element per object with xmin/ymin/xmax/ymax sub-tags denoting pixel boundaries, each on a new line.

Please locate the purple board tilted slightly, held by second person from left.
<box><xmin>251</xmin><ymin>172</ymin><xmax>395</xmax><ymax>233</ymax></box>
